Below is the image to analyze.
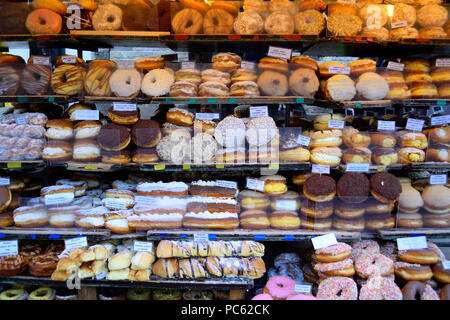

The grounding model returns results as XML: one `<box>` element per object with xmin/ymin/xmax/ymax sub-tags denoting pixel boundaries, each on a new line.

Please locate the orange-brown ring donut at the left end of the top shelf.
<box><xmin>25</xmin><ymin>9</ymin><xmax>62</xmax><ymax>34</ymax></box>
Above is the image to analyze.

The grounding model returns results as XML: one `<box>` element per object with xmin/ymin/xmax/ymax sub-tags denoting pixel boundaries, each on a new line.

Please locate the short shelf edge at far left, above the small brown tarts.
<box><xmin>0</xmin><ymin>227</ymin><xmax>111</xmax><ymax>241</ymax></box>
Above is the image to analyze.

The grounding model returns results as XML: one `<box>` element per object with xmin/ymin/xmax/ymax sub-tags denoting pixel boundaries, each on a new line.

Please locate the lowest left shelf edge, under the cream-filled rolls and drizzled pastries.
<box><xmin>0</xmin><ymin>275</ymin><xmax>253</xmax><ymax>290</ymax></box>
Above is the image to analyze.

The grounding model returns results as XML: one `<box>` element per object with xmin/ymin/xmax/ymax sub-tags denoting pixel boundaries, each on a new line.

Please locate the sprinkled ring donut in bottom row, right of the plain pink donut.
<box><xmin>316</xmin><ymin>277</ymin><xmax>358</xmax><ymax>300</ymax></box>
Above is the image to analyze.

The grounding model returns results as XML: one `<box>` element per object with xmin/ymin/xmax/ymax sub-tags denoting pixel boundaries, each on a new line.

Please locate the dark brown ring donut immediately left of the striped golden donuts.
<box><xmin>20</xmin><ymin>64</ymin><xmax>52</xmax><ymax>95</ymax></box>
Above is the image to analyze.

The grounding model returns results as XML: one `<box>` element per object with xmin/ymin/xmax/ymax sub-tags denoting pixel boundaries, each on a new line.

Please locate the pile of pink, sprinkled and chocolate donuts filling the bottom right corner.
<box><xmin>253</xmin><ymin>240</ymin><xmax>450</xmax><ymax>300</ymax></box>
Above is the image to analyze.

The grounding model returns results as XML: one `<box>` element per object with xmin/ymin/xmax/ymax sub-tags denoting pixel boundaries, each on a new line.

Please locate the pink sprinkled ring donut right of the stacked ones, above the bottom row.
<box><xmin>355</xmin><ymin>253</ymin><xmax>394</xmax><ymax>279</ymax></box>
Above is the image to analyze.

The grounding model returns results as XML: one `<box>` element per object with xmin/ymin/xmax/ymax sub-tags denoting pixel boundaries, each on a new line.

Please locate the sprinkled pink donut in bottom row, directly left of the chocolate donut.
<box><xmin>359</xmin><ymin>276</ymin><xmax>403</xmax><ymax>300</ymax></box>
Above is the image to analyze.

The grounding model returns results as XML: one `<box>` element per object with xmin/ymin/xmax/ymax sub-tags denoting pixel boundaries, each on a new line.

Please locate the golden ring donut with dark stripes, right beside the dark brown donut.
<box><xmin>52</xmin><ymin>64</ymin><xmax>84</xmax><ymax>96</ymax></box>
